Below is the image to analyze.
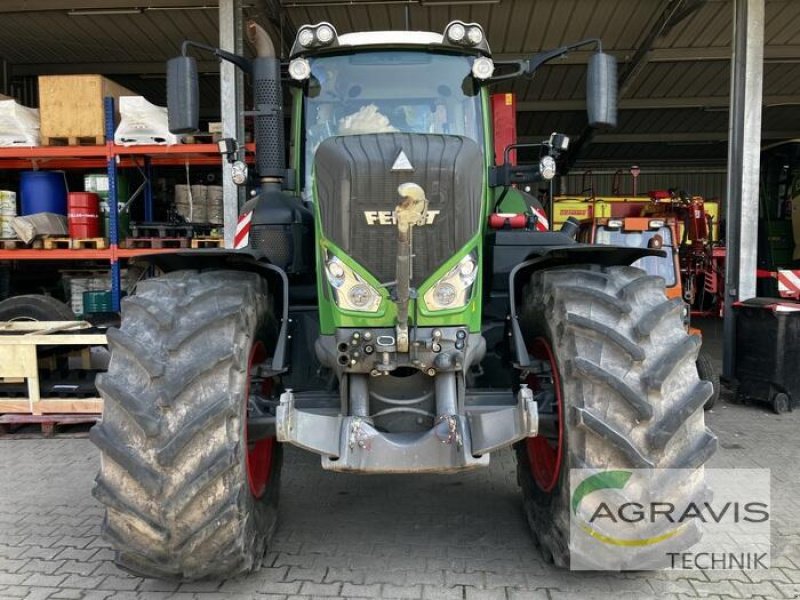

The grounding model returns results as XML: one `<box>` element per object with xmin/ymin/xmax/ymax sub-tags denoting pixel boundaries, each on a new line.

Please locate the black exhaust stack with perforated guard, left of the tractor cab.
<box><xmin>247</xmin><ymin>21</ymin><xmax>286</xmax><ymax>189</ymax></box>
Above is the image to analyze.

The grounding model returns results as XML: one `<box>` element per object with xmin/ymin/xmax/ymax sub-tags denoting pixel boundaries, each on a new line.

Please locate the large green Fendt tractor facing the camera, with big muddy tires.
<box><xmin>91</xmin><ymin>21</ymin><xmax>716</xmax><ymax>580</ymax></box>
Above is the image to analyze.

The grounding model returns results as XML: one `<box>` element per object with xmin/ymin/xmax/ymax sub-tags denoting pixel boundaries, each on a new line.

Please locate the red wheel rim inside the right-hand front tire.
<box><xmin>526</xmin><ymin>338</ymin><xmax>564</xmax><ymax>492</ymax></box>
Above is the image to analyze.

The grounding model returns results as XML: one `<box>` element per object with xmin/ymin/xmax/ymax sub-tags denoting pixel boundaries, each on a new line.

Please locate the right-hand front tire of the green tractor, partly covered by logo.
<box><xmin>516</xmin><ymin>266</ymin><xmax>717</xmax><ymax>569</ymax></box>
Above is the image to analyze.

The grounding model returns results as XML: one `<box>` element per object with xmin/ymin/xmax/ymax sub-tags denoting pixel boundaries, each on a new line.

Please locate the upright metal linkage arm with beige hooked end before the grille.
<box><xmin>394</xmin><ymin>183</ymin><xmax>428</xmax><ymax>352</ymax></box>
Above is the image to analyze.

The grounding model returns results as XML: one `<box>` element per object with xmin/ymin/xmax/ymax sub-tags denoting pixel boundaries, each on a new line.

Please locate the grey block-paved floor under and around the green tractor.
<box><xmin>0</xmin><ymin>322</ymin><xmax>800</xmax><ymax>600</ymax></box>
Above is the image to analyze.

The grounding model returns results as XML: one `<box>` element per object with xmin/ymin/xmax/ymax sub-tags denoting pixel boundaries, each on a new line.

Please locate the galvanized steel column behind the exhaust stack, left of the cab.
<box><xmin>219</xmin><ymin>0</ymin><xmax>245</xmax><ymax>248</ymax></box>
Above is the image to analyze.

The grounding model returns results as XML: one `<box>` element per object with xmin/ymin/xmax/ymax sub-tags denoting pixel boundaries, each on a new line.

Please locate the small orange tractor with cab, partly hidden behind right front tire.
<box><xmin>577</xmin><ymin>216</ymin><xmax>720</xmax><ymax>410</ymax></box>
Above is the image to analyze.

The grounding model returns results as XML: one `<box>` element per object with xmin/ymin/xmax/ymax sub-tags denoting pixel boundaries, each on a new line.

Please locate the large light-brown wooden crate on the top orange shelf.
<box><xmin>39</xmin><ymin>75</ymin><xmax>137</xmax><ymax>146</ymax></box>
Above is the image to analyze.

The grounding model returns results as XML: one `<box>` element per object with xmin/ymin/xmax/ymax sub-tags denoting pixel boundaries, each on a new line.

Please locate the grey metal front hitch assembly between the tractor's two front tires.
<box><xmin>276</xmin><ymin>328</ymin><xmax>538</xmax><ymax>473</ymax></box>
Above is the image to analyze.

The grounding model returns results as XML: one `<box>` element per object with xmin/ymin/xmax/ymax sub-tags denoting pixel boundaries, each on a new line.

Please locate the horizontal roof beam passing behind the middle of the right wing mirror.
<box><xmin>517</xmin><ymin>95</ymin><xmax>800</xmax><ymax>112</ymax></box>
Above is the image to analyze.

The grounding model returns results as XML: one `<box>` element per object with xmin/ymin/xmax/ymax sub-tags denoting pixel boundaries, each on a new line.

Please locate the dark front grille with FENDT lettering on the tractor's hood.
<box><xmin>315</xmin><ymin>133</ymin><xmax>484</xmax><ymax>285</ymax></box>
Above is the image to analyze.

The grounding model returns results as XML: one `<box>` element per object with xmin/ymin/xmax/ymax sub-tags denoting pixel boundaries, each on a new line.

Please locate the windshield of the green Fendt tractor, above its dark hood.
<box><xmin>303</xmin><ymin>50</ymin><xmax>483</xmax><ymax>194</ymax></box>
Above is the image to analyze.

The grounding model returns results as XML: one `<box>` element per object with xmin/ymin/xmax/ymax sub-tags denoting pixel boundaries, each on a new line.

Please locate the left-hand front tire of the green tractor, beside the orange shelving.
<box><xmin>90</xmin><ymin>271</ymin><xmax>281</xmax><ymax>580</ymax></box>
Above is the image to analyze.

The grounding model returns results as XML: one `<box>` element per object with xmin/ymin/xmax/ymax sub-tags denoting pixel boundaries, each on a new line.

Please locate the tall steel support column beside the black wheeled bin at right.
<box><xmin>722</xmin><ymin>0</ymin><xmax>764</xmax><ymax>378</ymax></box>
